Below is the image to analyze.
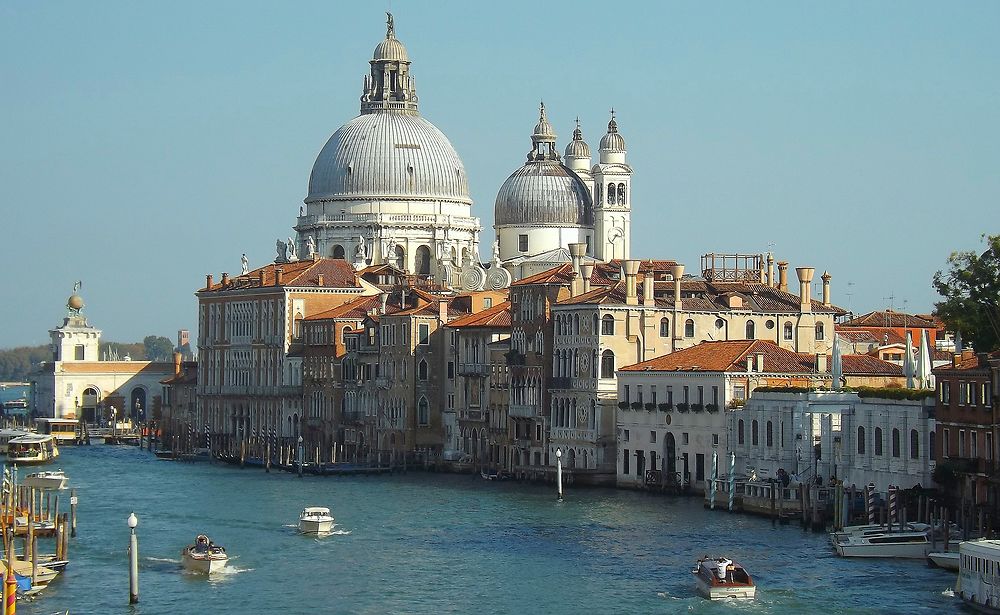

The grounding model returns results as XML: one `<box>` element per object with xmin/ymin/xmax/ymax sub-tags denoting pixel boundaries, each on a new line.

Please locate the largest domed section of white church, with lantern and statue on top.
<box><xmin>292</xmin><ymin>15</ymin><xmax>486</xmax><ymax>290</ymax></box>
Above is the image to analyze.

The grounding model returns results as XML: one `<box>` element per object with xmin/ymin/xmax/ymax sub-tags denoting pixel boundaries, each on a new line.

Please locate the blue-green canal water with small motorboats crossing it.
<box><xmin>18</xmin><ymin>445</ymin><xmax>958</xmax><ymax>615</ymax></box>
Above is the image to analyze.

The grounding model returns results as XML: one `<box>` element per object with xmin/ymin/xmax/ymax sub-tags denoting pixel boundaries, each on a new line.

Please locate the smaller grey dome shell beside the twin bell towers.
<box><xmin>494</xmin><ymin>160</ymin><xmax>594</xmax><ymax>226</ymax></box>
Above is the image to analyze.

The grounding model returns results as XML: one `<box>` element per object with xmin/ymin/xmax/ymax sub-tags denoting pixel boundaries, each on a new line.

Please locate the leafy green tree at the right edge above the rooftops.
<box><xmin>934</xmin><ymin>235</ymin><xmax>1000</xmax><ymax>352</ymax></box>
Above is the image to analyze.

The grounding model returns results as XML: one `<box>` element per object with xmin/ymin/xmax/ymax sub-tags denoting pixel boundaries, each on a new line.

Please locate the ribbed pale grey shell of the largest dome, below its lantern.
<box><xmin>306</xmin><ymin>113</ymin><xmax>472</xmax><ymax>204</ymax></box>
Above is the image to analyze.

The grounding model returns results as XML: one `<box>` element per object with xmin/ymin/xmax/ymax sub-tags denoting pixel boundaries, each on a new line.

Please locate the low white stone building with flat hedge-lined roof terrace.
<box><xmin>729</xmin><ymin>391</ymin><xmax>935</xmax><ymax>493</ymax></box>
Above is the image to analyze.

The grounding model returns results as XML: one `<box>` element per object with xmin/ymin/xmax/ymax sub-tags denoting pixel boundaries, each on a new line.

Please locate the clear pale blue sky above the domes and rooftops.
<box><xmin>0</xmin><ymin>0</ymin><xmax>1000</xmax><ymax>348</ymax></box>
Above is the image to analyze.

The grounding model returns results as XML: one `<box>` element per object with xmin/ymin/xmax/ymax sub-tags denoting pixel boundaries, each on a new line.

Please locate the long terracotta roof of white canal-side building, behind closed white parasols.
<box><xmin>621</xmin><ymin>340</ymin><xmax>815</xmax><ymax>373</ymax></box>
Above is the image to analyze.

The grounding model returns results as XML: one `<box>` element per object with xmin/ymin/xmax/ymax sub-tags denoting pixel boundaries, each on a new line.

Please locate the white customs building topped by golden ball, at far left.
<box><xmin>31</xmin><ymin>292</ymin><xmax>174</xmax><ymax>423</ymax></box>
